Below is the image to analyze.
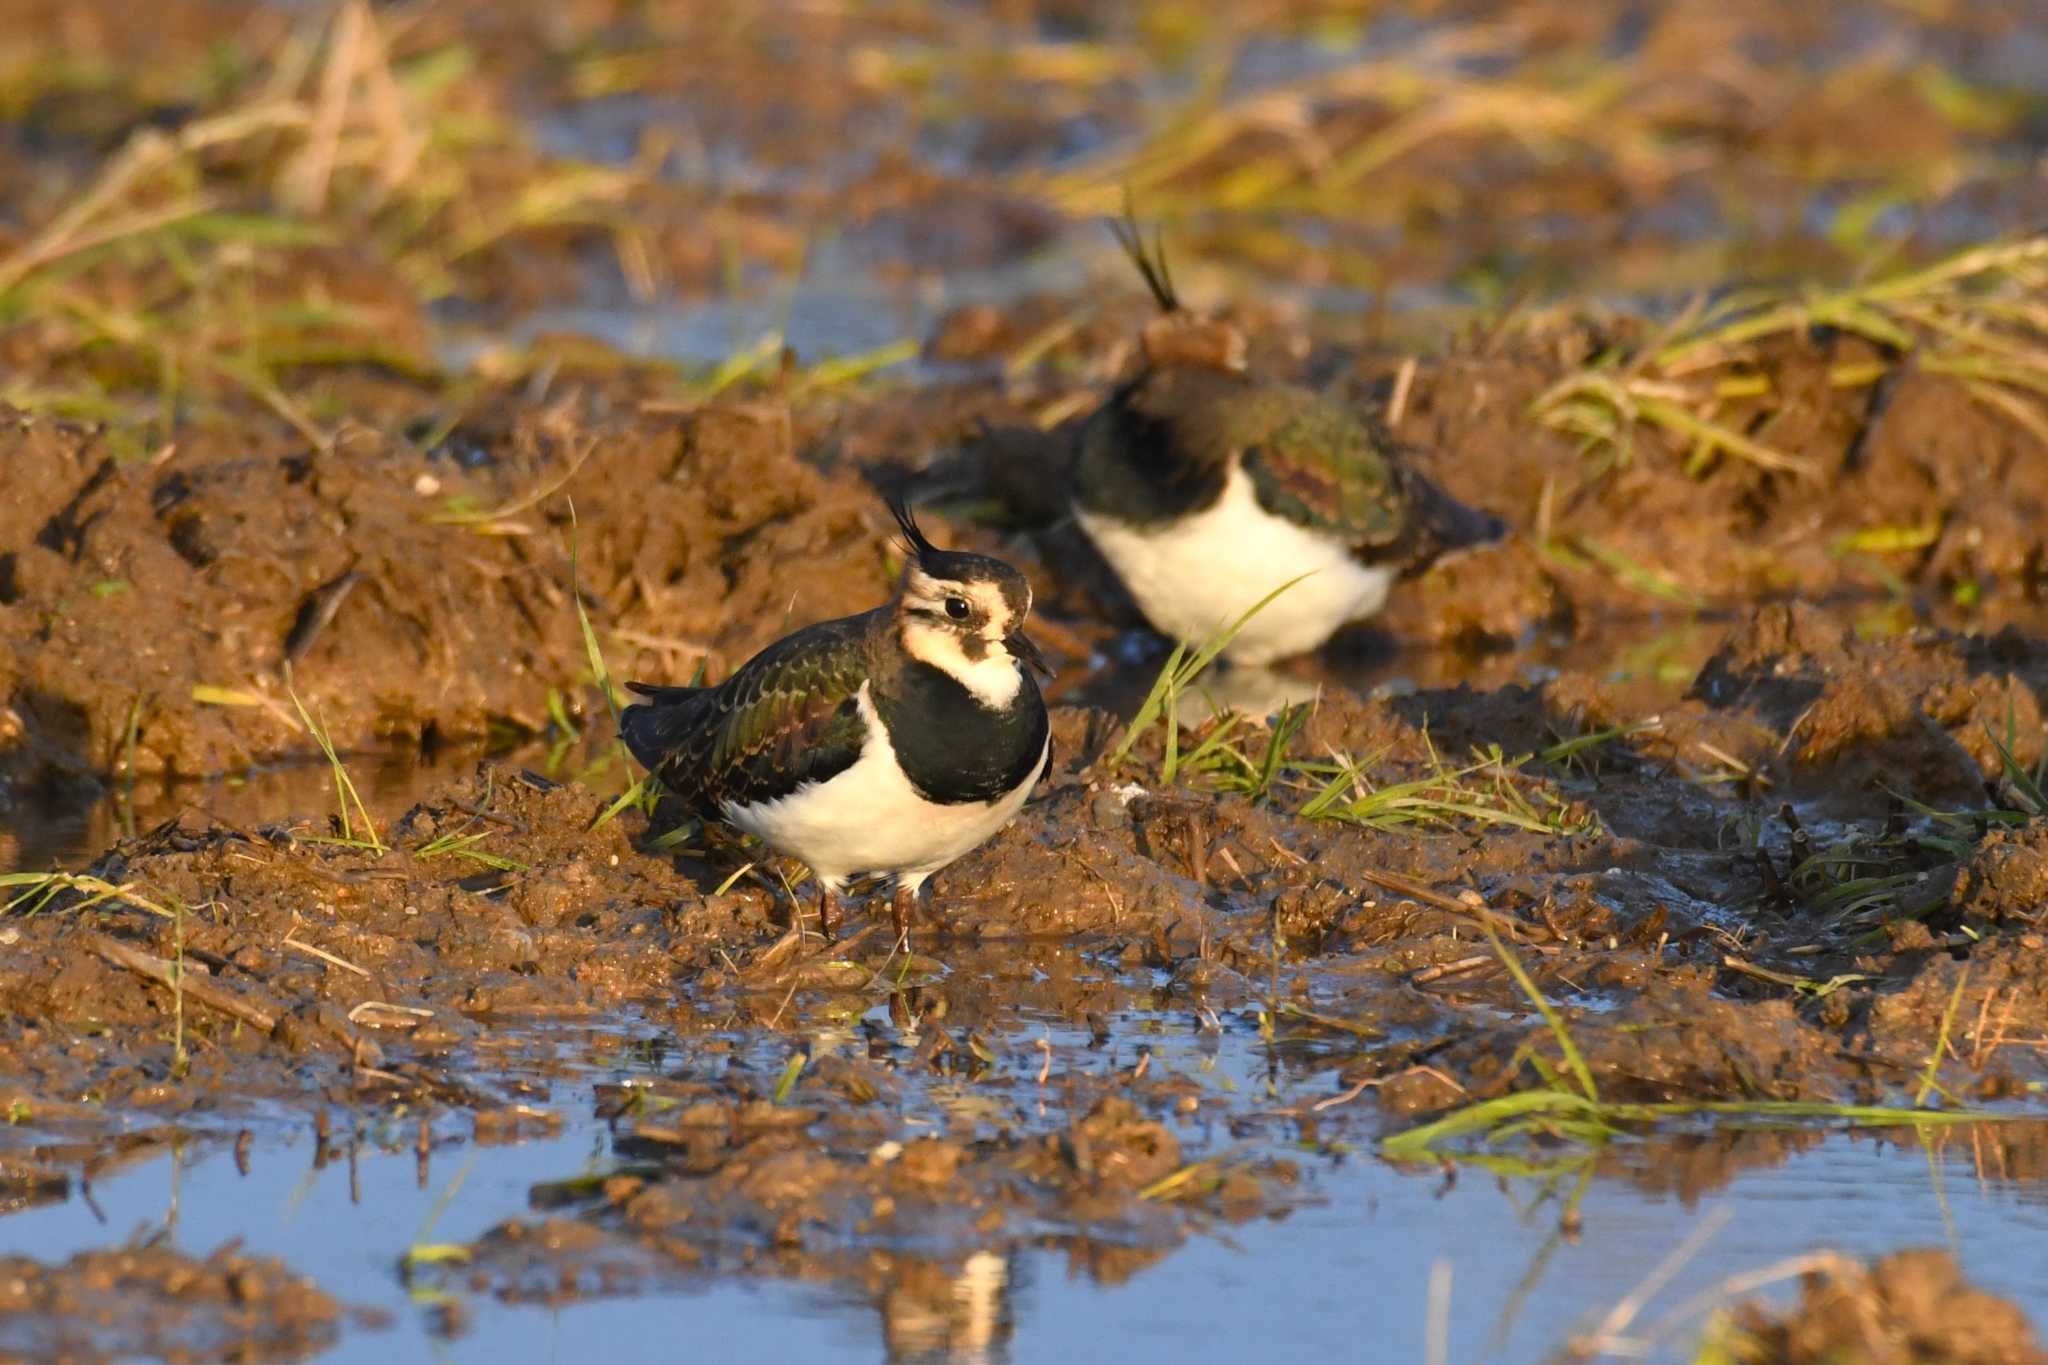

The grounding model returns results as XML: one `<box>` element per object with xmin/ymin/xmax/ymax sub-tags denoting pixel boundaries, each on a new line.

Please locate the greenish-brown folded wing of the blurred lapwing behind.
<box><xmin>1231</xmin><ymin>385</ymin><xmax>1407</xmax><ymax>551</ymax></box>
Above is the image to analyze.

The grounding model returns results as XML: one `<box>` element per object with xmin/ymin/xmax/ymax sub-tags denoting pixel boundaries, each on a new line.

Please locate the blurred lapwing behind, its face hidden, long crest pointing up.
<box><xmin>1073</xmin><ymin>217</ymin><xmax>1503</xmax><ymax>665</ymax></box>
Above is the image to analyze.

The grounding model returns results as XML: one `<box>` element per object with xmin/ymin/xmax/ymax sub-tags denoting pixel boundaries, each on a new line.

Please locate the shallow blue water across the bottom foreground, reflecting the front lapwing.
<box><xmin>0</xmin><ymin>994</ymin><xmax>2048</xmax><ymax>1361</ymax></box>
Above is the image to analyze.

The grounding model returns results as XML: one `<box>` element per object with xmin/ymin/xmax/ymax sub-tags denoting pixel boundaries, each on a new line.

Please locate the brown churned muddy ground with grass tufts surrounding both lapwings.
<box><xmin>0</xmin><ymin>4</ymin><xmax>2048</xmax><ymax>1361</ymax></box>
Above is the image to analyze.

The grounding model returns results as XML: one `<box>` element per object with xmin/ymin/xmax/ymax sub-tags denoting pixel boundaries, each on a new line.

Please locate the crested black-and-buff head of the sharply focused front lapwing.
<box><xmin>889</xmin><ymin>499</ymin><xmax>1053</xmax><ymax>706</ymax></box>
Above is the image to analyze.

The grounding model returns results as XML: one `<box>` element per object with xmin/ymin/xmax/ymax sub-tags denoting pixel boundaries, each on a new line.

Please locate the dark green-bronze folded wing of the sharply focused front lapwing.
<box><xmin>664</xmin><ymin>612</ymin><xmax>874</xmax><ymax>806</ymax></box>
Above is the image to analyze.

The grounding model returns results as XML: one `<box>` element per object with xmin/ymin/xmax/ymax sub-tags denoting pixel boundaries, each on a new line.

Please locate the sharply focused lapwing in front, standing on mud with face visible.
<box><xmin>618</xmin><ymin>501</ymin><xmax>1053</xmax><ymax>943</ymax></box>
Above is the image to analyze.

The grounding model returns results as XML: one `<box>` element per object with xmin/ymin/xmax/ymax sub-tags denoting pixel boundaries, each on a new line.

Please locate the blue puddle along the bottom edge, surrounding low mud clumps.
<box><xmin>0</xmin><ymin>994</ymin><xmax>2048</xmax><ymax>1361</ymax></box>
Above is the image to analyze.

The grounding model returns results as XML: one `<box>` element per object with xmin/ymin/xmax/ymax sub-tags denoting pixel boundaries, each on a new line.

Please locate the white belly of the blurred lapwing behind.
<box><xmin>1075</xmin><ymin>463</ymin><xmax>1393</xmax><ymax>663</ymax></box>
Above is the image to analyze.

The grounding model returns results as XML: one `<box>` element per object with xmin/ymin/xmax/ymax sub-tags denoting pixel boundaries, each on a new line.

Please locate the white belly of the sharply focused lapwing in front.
<box><xmin>723</xmin><ymin>684</ymin><xmax>1051</xmax><ymax>890</ymax></box>
